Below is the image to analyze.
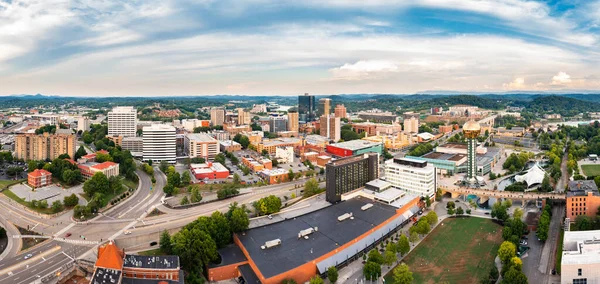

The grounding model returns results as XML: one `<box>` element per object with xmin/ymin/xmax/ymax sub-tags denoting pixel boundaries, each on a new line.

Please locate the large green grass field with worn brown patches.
<box><xmin>385</xmin><ymin>217</ymin><xmax>502</xmax><ymax>283</ymax></box>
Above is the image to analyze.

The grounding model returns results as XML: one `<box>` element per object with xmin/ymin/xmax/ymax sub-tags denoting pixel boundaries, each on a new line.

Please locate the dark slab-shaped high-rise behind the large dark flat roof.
<box><xmin>325</xmin><ymin>153</ymin><xmax>379</xmax><ymax>203</ymax></box>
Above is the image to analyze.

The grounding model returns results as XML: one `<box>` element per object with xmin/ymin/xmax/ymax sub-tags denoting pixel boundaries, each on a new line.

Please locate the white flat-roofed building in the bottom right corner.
<box><xmin>560</xmin><ymin>230</ymin><xmax>600</xmax><ymax>284</ymax></box>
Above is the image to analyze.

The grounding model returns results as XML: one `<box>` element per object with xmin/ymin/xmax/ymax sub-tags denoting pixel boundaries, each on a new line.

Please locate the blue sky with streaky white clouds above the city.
<box><xmin>0</xmin><ymin>0</ymin><xmax>600</xmax><ymax>97</ymax></box>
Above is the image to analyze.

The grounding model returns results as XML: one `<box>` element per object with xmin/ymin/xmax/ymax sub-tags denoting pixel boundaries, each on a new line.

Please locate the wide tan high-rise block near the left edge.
<box><xmin>15</xmin><ymin>129</ymin><xmax>77</xmax><ymax>161</ymax></box>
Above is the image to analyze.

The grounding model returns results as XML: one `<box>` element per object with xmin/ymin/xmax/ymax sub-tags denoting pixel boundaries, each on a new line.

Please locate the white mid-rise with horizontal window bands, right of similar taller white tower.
<box><xmin>143</xmin><ymin>124</ymin><xmax>176</xmax><ymax>163</ymax></box>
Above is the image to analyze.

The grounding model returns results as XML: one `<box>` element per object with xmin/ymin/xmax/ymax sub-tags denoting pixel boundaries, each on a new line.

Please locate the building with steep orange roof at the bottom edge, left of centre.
<box><xmin>89</xmin><ymin>241</ymin><xmax>184</xmax><ymax>284</ymax></box>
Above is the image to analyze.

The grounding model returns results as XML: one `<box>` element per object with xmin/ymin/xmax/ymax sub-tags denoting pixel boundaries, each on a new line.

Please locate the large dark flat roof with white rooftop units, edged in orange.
<box><xmin>238</xmin><ymin>197</ymin><xmax>396</xmax><ymax>278</ymax></box>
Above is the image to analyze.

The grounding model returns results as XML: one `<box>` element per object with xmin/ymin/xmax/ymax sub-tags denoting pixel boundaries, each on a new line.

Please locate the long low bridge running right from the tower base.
<box><xmin>440</xmin><ymin>186</ymin><xmax>566</xmax><ymax>200</ymax></box>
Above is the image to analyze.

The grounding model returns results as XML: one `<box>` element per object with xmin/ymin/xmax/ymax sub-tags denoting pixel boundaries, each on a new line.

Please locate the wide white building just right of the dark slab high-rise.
<box><xmin>385</xmin><ymin>158</ymin><xmax>437</xmax><ymax>197</ymax></box>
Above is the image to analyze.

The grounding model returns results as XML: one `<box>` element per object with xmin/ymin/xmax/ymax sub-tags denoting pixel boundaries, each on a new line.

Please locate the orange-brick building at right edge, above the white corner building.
<box><xmin>565</xmin><ymin>180</ymin><xmax>600</xmax><ymax>221</ymax></box>
